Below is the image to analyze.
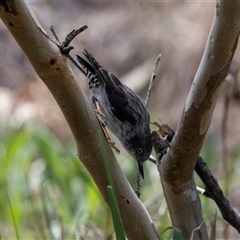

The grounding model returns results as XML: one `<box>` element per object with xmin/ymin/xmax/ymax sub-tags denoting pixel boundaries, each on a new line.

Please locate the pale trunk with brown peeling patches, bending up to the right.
<box><xmin>159</xmin><ymin>1</ymin><xmax>240</xmax><ymax>239</ymax></box>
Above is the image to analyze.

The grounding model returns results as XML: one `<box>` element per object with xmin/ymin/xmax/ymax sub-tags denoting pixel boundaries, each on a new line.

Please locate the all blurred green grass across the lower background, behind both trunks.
<box><xmin>0</xmin><ymin>117</ymin><xmax>239</xmax><ymax>239</ymax></box>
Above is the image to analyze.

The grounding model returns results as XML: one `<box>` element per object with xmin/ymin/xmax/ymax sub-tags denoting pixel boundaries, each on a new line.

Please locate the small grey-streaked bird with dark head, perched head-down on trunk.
<box><xmin>76</xmin><ymin>49</ymin><xmax>152</xmax><ymax>179</ymax></box>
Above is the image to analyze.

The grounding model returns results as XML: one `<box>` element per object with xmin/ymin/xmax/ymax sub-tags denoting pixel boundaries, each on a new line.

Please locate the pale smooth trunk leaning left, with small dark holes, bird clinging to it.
<box><xmin>0</xmin><ymin>0</ymin><xmax>160</xmax><ymax>240</ymax></box>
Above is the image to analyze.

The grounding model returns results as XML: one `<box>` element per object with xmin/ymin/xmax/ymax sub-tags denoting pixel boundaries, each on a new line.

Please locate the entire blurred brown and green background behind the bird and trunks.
<box><xmin>0</xmin><ymin>0</ymin><xmax>240</xmax><ymax>239</ymax></box>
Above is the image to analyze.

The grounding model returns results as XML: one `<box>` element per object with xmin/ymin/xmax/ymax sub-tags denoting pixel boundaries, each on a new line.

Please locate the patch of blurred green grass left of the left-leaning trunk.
<box><xmin>0</xmin><ymin>123</ymin><xmax>106</xmax><ymax>239</ymax></box>
